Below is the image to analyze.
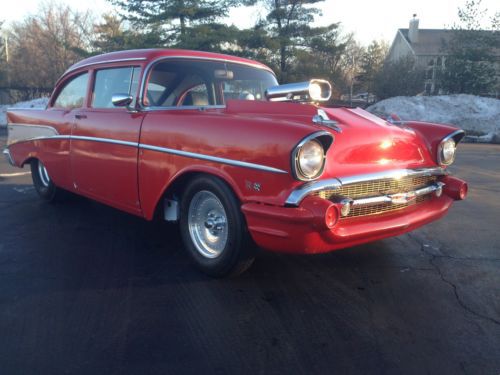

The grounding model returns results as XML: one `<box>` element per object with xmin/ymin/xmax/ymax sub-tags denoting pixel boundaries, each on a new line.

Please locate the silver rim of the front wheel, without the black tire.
<box><xmin>188</xmin><ymin>190</ymin><xmax>228</xmax><ymax>259</ymax></box>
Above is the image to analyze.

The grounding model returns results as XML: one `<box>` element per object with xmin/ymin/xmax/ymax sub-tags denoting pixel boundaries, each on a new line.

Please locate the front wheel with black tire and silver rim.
<box><xmin>180</xmin><ymin>176</ymin><xmax>254</xmax><ymax>277</ymax></box>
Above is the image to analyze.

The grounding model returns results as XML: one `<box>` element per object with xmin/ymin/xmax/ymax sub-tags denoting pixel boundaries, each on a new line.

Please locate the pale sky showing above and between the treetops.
<box><xmin>0</xmin><ymin>0</ymin><xmax>500</xmax><ymax>44</ymax></box>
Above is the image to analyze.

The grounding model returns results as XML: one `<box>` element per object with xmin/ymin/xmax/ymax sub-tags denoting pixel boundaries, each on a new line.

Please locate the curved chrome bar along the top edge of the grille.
<box><xmin>285</xmin><ymin>167</ymin><xmax>448</xmax><ymax>207</ymax></box>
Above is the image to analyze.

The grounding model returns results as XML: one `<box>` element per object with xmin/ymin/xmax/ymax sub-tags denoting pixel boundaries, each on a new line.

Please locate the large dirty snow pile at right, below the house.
<box><xmin>367</xmin><ymin>94</ymin><xmax>500</xmax><ymax>142</ymax></box>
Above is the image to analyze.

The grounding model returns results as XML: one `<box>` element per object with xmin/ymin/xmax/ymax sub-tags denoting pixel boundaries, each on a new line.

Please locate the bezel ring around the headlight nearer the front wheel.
<box><xmin>291</xmin><ymin>131</ymin><xmax>333</xmax><ymax>181</ymax></box>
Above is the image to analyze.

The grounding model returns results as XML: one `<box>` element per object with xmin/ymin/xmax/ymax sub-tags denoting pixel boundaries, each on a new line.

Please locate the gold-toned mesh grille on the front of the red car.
<box><xmin>313</xmin><ymin>176</ymin><xmax>438</xmax><ymax>219</ymax></box>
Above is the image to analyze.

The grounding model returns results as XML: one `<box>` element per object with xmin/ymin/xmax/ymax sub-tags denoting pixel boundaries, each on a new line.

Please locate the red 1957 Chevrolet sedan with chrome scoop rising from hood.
<box><xmin>4</xmin><ymin>50</ymin><xmax>467</xmax><ymax>276</ymax></box>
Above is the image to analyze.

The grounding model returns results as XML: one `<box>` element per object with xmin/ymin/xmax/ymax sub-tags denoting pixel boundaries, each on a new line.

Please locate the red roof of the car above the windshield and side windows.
<box><xmin>63</xmin><ymin>49</ymin><xmax>271</xmax><ymax>76</ymax></box>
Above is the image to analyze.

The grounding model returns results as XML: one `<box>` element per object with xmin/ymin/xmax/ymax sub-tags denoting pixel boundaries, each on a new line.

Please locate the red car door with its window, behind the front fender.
<box><xmin>70</xmin><ymin>66</ymin><xmax>144</xmax><ymax>214</ymax></box>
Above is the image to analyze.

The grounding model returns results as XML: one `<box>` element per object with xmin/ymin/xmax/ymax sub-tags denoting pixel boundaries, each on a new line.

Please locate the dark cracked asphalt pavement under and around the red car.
<box><xmin>0</xmin><ymin>136</ymin><xmax>500</xmax><ymax>375</ymax></box>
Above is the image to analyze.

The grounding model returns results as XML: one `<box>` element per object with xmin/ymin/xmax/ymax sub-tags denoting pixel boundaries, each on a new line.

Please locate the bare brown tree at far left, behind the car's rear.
<box><xmin>9</xmin><ymin>2</ymin><xmax>92</xmax><ymax>88</ymax></box>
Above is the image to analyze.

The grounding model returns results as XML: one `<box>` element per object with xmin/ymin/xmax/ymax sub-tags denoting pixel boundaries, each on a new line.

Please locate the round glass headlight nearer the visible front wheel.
<box><xmin>295</xmin><ymin>139</ymin><xmax>325</xmax><ymax>180</ymax></box>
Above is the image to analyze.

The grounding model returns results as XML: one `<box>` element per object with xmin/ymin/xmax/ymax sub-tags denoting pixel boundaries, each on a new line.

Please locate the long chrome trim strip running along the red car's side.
<box><xmin>4</xmin><ymin>135</ymin><xmax>288</xmax><ymax>174</ymax></box>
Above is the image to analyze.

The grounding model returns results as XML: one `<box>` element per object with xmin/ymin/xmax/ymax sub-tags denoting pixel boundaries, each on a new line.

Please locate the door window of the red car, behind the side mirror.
<box><xmin>92</xmin><ymin>67</ymin><xmax>140</xmax><ymax>108</ymax></box>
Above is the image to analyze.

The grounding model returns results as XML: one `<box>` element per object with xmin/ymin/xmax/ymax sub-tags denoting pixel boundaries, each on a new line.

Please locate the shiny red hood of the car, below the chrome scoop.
<box><xmin>227</xmin><ymin>101</ymin><xmax>436</xmax><ymax>178</ymax></box>
